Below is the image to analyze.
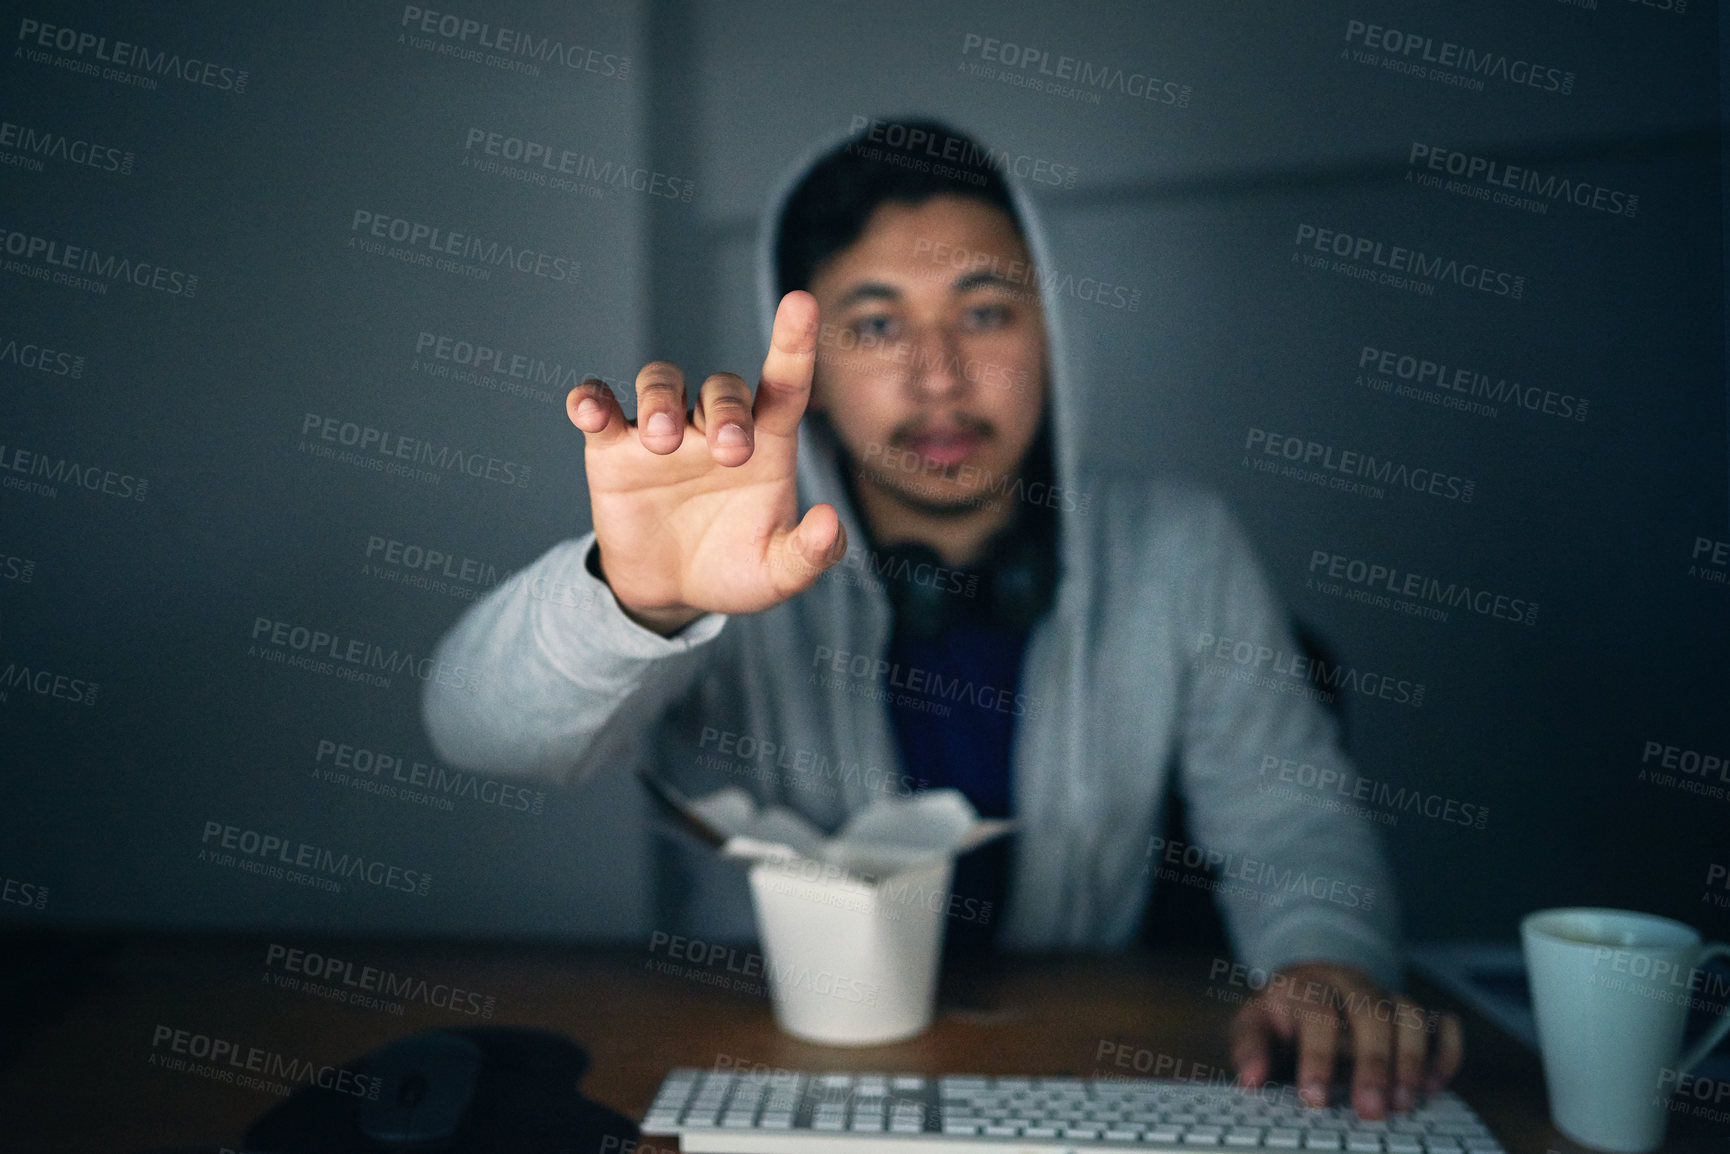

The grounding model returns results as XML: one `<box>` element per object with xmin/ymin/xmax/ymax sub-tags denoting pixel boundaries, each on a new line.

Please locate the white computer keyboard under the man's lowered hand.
<box><xmin>642</xmin><ymin>1069</ymin><xmax>1502</xmax><ymax>1154</ymax></box>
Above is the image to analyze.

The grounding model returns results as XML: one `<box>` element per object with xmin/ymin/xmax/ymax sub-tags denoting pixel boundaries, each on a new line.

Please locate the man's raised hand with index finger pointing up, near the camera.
<box><xmin>566</xmin><ymin>292</ymin><xmax>846</xmax><ymax>635</ymax></box>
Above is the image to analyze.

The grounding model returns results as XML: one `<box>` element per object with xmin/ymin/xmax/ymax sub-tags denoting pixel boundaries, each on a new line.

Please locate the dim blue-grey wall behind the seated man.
<box><xmin>0</xmin><ymin>0</ymin><xmax>1730</xmax><ymax>941</ymax></box>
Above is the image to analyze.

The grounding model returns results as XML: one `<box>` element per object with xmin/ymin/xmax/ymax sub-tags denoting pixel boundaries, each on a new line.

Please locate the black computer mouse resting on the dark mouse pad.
<box><xmin>355</xmin><ymin>1029</ymin><xmax>481</xmax><ymax>1145</ymax></box>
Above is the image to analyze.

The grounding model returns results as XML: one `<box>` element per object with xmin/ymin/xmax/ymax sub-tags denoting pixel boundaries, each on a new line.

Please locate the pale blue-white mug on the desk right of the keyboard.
<box><xmin>1519</xmin><ymin>908</ymin><xmax>1730</xmax><ymax>1154</ymax></box>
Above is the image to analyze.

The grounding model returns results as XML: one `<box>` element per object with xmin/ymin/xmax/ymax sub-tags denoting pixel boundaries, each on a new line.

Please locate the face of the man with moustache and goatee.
<box><xmin>811</xmin><ymin>196</ymin><xmax>1045</xmax><ymax>514</ymax></box>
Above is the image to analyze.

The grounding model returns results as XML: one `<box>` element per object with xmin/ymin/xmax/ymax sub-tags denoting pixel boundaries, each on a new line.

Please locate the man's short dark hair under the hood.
<box><xmin>775</xmin><ymin>118</ymin><xmax>1021</xmax><ymax>296</ymax></box>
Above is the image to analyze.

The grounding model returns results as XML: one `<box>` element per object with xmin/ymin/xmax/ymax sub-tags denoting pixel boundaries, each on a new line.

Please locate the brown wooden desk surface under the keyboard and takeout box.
<box><xmin>0</xmin><ymin>934</ymin><xmax>1730</xmax><ymax>1154</ymax></box>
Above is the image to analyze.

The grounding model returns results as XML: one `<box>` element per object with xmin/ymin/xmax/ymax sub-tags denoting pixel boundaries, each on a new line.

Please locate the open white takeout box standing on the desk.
<box><xmin>692</xmin><ymin>787</ymin><xmax>1012</xmax><ymax>1045</ymax></box>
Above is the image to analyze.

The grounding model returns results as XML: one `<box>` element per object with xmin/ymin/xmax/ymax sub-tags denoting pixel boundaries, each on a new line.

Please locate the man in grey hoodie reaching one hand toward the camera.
<box><xmin>426</xmin><ymin>123</ymin><xmax>1460</xmax><ymax>1118</ymax></box>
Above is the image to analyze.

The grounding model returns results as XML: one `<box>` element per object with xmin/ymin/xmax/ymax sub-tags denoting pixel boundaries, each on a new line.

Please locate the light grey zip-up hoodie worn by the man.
<box><xmin>424</xmin><ymin>128</ymin><xmax>1400</xmax><ymax>984</ymax></box>
